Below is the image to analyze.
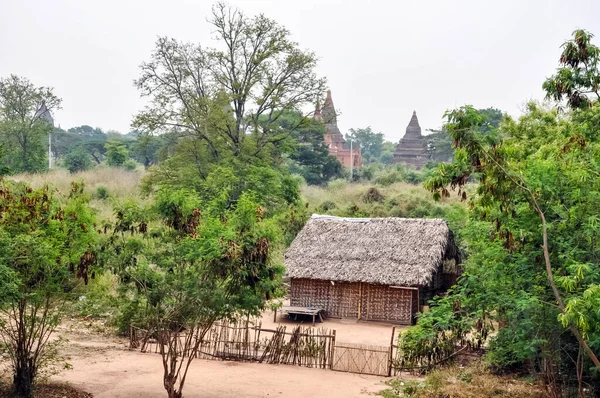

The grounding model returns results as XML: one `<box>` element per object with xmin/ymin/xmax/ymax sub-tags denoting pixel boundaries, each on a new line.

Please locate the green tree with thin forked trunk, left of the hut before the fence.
<box><xmin>109</xmin><ymin>190</ymin><xmax>282</xmax><ymax>398</ymax></box>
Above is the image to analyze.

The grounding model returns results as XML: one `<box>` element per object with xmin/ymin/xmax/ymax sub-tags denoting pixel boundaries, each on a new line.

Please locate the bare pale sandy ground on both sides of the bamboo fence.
<box><xmin>47</xmin><ymin>312</ymin><xmax>404</xmax><ymax>398</ymax></box>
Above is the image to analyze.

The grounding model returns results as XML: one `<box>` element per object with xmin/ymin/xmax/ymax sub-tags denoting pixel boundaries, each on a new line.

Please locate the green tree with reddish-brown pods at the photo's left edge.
<box><xmin>0</xmin><ymin>181</ymin><xmax>96</xmax><ymax>397</ymax></box>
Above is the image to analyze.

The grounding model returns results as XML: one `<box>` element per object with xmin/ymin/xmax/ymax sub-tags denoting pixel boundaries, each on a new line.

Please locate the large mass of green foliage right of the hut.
<box><xmin>402</xmin><ymin>96</ymin><xmax>600</xmax><ymax>388</ymax></box>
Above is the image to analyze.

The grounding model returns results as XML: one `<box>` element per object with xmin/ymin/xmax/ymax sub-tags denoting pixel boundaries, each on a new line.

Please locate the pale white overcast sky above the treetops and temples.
<box><xmin>0</xmin><ymin>0</ymin><xmax>600</xmax><ymax>141</ymax></box>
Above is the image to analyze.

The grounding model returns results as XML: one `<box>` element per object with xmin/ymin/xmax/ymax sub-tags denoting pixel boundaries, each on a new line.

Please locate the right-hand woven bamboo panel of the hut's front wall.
<box><xmin>361</xmin><ymin>284</ymin><xmax>414</xmax><ymax>324</ymax></box>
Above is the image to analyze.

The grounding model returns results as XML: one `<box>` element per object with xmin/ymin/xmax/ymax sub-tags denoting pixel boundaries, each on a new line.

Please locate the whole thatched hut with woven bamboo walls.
<box><xmin>285</xmin><ymin>215</ymin><xmax>460</xmax><ymax>320</ymax></box>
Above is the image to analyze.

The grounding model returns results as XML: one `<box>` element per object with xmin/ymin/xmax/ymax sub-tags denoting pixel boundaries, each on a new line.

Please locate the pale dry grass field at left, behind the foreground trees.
<box><xmin>10</xmin><ymin>166</ymin><xmax>144</xmax><ymax>220</ymax></box>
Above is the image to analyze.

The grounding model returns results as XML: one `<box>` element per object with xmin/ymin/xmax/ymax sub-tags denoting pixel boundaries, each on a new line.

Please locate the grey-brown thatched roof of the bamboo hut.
<box><xmin>285</xmin><ymin>215</ymin><xmax>458</xmax><ymax>286</ymax></box>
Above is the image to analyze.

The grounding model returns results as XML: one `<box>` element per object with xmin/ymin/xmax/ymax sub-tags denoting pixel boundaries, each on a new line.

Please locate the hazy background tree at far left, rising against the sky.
<box><xmin>0</xmin><ymin>75</ymin><xmax>61</xmax><ymax>173</ymax></box>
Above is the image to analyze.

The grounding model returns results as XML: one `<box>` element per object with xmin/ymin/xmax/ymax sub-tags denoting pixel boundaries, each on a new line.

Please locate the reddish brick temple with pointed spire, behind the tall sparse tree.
<box><xmin>314</xmin><ymin>90</ymin><xmax>362</xmax><ymax>167</ymax></box>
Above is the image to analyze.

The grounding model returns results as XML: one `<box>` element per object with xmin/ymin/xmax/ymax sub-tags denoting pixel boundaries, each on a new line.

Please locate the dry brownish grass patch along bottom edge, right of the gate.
<box><xmin>380</xmin><ymin>364</ymin><xmax>547</xmax><ymax>398</ymax></box>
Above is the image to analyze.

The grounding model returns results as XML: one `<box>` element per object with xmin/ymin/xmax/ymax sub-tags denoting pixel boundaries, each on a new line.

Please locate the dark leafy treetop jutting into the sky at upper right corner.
<box><xmin>543</xmin><ymin>29</ymin><xmax>600</xmax><ymax>109</ymax></box>
